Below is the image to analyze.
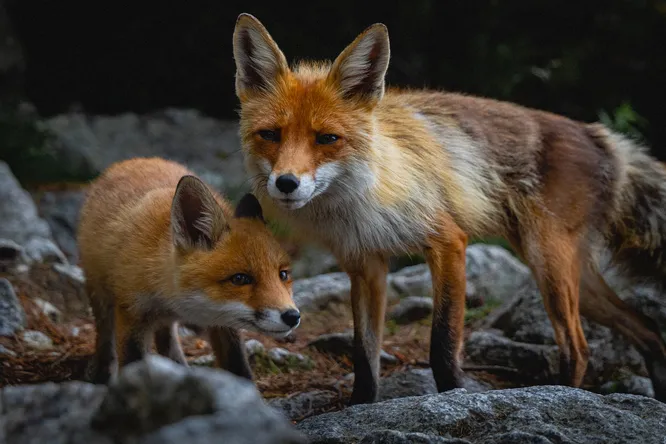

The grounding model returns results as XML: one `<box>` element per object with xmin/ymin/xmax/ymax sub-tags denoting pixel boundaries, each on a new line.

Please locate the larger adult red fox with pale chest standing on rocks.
<box><xmin>233</xmin><ymin>14</ymin><xmax>666</xmax><ymax>404</ymax></box>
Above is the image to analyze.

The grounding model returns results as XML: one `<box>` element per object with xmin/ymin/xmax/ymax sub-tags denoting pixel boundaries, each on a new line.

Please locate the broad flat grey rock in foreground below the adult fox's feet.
<box><xmin>297</xmin><ymin>386</ymin><xmax>666</xmax><ymax>444</ymax></box>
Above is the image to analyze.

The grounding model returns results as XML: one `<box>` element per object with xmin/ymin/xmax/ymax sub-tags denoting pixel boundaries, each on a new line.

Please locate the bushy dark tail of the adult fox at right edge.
<box><xmin>594</xmin><ymin>125</ymin><xmax>666</xmax><ymax>285</ymax></box>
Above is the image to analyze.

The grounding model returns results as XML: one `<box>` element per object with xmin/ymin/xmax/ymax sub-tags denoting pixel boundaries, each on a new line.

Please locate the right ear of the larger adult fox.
<box><xmin>328</xmin><ymin>23</ymin><xmax>391</xmax><ymax>104</ymax></box>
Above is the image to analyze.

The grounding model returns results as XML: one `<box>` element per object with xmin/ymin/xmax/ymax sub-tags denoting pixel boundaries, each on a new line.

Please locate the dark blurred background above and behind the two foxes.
<box><xmin>0</xmin><ymin>0</ymin><xmax>666</xmax><ymax>262</ymax></box>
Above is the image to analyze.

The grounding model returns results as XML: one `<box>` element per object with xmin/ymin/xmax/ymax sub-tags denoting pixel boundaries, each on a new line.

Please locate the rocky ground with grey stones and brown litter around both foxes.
<box><xmin>0</xmin><ymin>110</ymin><xmax>666</xmax><ymax>443</ymax></box>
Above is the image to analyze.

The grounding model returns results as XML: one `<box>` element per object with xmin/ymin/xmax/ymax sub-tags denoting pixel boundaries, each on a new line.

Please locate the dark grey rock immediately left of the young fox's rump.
<box><xmin>37</xmin><ymin>191</ymin><xmax>85</xmax><ymax>264</ymax></box>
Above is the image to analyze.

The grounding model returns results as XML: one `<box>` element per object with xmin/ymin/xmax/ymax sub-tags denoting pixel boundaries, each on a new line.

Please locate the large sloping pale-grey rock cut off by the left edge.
<box><xmin>0</xmin><ymin>161</ymin><xmax>66</xmax><ymax>262</ymax></box>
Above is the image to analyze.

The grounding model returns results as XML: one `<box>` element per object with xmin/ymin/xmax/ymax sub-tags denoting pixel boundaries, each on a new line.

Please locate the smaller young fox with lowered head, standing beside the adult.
<box><xmin>78</xmin><ymin>158</ymin><xmax>300</xmax><ymax>383</ymax></box>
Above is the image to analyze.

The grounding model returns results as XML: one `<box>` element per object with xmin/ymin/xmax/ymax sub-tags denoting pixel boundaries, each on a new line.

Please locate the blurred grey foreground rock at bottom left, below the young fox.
<box><xmin>0</xmin><ymin>356</ymin><xmax>306</xmax><ymax>444</ymax></box>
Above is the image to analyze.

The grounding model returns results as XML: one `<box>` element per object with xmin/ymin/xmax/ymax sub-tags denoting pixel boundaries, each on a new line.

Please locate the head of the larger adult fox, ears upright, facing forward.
<box><xmin>233</xmin><ymin>14</ymin><xmax>390</xmax><ymax>210</ymax></box>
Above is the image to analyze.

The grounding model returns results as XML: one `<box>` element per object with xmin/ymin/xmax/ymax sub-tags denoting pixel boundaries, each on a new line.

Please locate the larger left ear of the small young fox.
<box><xmin>171</xmin><ymin>176</ymin><xmax>229</xmax><ymax>250</ymax></box>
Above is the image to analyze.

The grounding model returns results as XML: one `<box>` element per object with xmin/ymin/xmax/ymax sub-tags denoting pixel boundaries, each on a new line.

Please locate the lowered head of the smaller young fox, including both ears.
<box><xmin>171</xmin><ymin>176</ymin><xmax>300</xmax><ymax>336</ymax></box>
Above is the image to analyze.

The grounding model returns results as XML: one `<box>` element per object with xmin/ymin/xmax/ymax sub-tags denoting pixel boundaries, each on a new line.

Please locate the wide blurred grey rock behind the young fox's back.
<box><xmin>45</xmin><ymin>109</ymin><xmax>248</xmax><ymax>199</ymax></box>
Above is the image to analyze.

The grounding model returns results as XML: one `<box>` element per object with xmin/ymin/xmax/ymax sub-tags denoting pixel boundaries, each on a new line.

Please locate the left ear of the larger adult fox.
<box><xmin>233</xmin><ymin>14</ymin><xmax>289</xmax><ymax>98</ymax></box>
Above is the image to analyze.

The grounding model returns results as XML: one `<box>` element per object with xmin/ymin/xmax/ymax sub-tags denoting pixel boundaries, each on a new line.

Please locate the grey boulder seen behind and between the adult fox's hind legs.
<box><xmin>465</xmin><ymin>280</ymin><xmax>652</xmax><ymax>388</ymax></box>
